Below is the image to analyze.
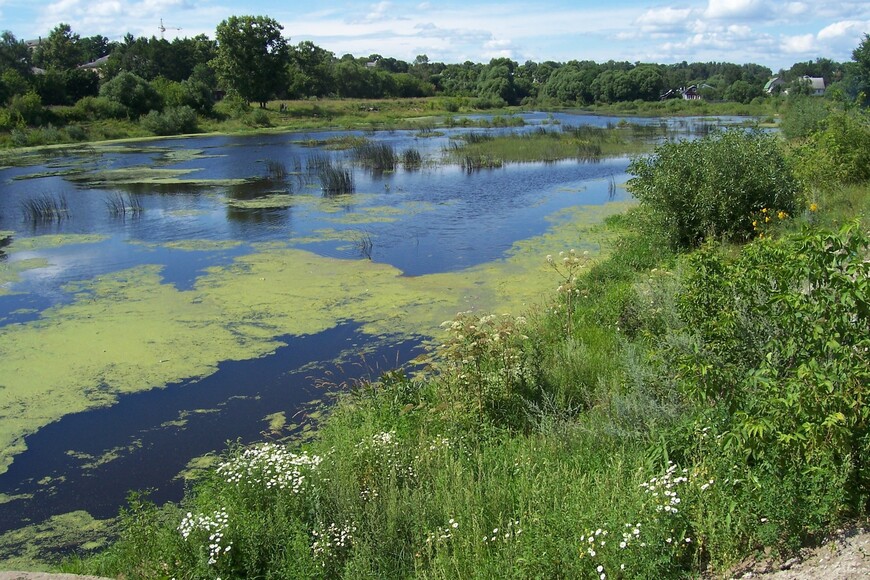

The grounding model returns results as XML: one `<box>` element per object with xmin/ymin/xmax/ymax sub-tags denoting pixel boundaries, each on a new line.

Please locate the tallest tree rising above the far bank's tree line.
<box><xmin>214</xmin><ymin>16</ymin><xmax>289</xmax><ymax>108</ymax></box>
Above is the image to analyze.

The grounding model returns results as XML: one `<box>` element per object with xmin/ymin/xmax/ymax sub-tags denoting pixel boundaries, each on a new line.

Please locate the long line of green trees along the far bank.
<box><xmin>0</xmin><ymin>16</ymin><xmax>868</xmax><ymax>130</ymax></box>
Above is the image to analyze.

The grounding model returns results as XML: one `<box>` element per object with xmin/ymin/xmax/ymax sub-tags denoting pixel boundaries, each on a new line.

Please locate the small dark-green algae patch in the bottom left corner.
<box><xmin>0</xmin><ymin>511</ymin><xmax>114</xmax><ymax>571</ymax></box>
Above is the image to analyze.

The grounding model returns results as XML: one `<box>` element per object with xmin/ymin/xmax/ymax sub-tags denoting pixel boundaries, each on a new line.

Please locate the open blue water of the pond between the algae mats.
<box><xmin>0</xmin><ymin>113</ymin><xmax>742</xmax><ymax>532</ymax></box>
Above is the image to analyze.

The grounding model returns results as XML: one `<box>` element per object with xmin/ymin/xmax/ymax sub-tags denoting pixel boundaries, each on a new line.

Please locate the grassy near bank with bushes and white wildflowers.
<box><xmin>58</xmin><ymin>106</ymin><xmax>870</xmax><ymax>579</ymax></box>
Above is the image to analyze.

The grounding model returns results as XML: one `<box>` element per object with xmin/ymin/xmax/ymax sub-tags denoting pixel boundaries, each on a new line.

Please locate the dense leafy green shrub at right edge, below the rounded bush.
<box><xmin>676</xmin><ymin>224</ymin><xmax>870</xmax><ymax>511</ymax></box>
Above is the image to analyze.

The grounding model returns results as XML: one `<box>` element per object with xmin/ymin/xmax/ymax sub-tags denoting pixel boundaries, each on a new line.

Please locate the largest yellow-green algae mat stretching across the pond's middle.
<box><xmin>0</xmin><ymin>204</ymin><xmax>624</xmax><ymax>473</ymax></box>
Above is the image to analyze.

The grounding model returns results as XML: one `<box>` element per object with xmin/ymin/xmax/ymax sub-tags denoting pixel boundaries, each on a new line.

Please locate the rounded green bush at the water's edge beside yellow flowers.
<box><xmin>629</xmin><ymin>129</ymin><xmax>798</xmax><ymax>248</ymax></box>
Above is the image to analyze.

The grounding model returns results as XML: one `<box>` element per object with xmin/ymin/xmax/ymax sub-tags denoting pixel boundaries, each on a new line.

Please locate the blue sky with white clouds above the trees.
<box><xmin>0</xmin><ymin>0</ymin><xmax>870</xmax><ymax>71</ymax></box>
